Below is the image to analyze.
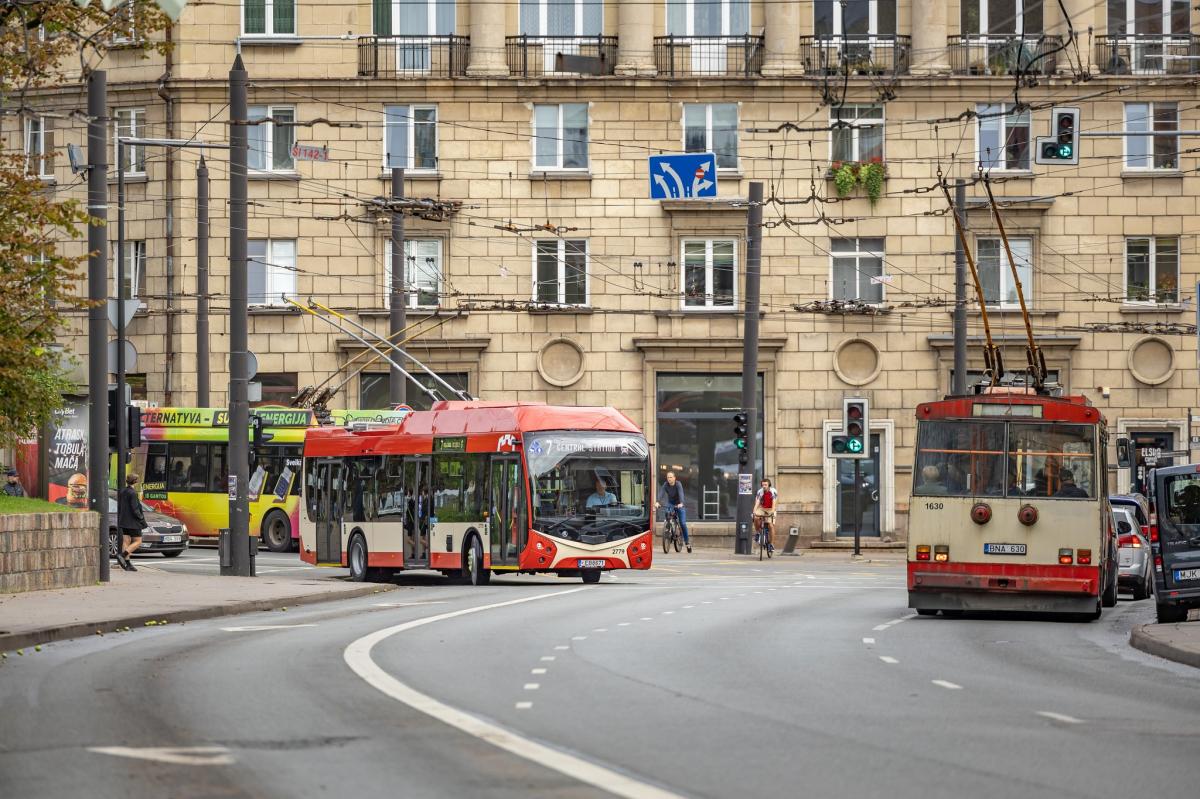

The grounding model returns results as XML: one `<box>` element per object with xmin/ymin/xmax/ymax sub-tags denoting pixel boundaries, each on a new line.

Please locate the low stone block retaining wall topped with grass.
<box><xmin>0</xmin><ymin>511</ymin><xmax>100</xmax><ymax>594</ymax></box>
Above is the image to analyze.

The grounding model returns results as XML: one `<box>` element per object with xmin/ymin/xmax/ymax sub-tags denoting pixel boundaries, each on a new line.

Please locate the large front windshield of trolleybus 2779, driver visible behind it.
<box><xmin>526</xmin><ymin>432</ymin><xmax>649</xmax><ymax>543</ymax></box>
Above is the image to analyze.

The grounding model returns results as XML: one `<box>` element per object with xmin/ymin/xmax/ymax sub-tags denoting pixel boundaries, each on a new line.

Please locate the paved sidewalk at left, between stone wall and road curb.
<box><xmin>0</xmin><ymin>563</ymin><xmax>396</xmax><ymax>651</ymax></box>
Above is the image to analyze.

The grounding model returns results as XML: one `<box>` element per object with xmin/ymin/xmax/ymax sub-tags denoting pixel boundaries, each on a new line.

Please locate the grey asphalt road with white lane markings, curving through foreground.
<box><xmin>0</xmin><ymin>555</ymin><xmax>1200</xmax><ymax>799</ymax></box>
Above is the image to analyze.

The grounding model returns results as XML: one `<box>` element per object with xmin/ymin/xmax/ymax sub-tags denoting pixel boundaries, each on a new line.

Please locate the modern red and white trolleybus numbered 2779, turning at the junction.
<box><xmin>300</xmin><ymin>401</ymin><xmax>653</xmax><ymax>584</ymax></box>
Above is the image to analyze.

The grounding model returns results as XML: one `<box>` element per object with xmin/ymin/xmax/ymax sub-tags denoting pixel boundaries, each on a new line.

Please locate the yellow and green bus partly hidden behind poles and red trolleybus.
<box><xmin>130</xmin><ymin>405</ymin><xmax>410</xmax><ymax>552</ymax></box>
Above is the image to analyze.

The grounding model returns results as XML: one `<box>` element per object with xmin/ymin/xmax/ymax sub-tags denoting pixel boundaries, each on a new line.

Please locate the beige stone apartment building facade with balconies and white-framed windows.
<box><xmin>6</xmin><ymin>0</ymin><xmax>1200</xmax><ymax>540</ymax></box>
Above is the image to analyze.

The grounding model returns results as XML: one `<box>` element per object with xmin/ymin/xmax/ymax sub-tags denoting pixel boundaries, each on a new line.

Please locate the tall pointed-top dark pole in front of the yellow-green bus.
<box><xmin>221</xmin><ymin>54</ymin><xmax>251</xmax><ymax>577</ymax></box>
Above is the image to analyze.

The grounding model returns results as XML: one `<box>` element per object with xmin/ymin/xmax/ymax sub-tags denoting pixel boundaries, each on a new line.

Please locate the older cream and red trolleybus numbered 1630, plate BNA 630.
<box><xmin>908</xmin><ymin>388</ymin><xmax>1117</xmax><ymax>619</ymax></box>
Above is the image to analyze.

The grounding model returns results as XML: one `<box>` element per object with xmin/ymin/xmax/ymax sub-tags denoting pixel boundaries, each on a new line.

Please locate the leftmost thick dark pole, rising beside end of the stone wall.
<box><xmin>88</xmin><ymin>70</ymin><xmax>109</xmax><ymax>583</ymax></box>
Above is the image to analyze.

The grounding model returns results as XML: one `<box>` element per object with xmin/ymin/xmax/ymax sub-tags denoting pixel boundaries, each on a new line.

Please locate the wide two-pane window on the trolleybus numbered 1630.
<box><xmin>912</xmin><ymin>420</ymin><xmax>1098</xmax><ymax>499</ymax></box>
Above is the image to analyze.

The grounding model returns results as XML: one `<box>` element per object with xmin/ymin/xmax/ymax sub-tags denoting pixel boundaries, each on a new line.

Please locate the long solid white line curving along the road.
<box><xmin>342</xmin><ymin>588</ymin><xmax>683</xmax><ymax>799</ymax></box>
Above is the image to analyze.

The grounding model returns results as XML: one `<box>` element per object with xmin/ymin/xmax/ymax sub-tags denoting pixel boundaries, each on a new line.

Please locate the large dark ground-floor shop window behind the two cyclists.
<box><xmin>655</xmin><ymin>373</ymin><xmax>766</xmax><ymax>522</ymax></box>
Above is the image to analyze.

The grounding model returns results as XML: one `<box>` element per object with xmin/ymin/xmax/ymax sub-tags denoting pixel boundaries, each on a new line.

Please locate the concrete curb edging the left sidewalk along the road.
<box><xmin>0</xmin><ymin>583</ymin><xmax>400</xmax><ymax>651</ymax></box>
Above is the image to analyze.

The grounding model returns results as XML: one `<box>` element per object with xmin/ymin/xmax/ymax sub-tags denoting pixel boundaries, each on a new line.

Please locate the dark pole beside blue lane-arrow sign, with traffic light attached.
<box><xmin>733</xmin><ymin>181</ymin><xmax>766</xmax><ymax>554</ymax></box>
